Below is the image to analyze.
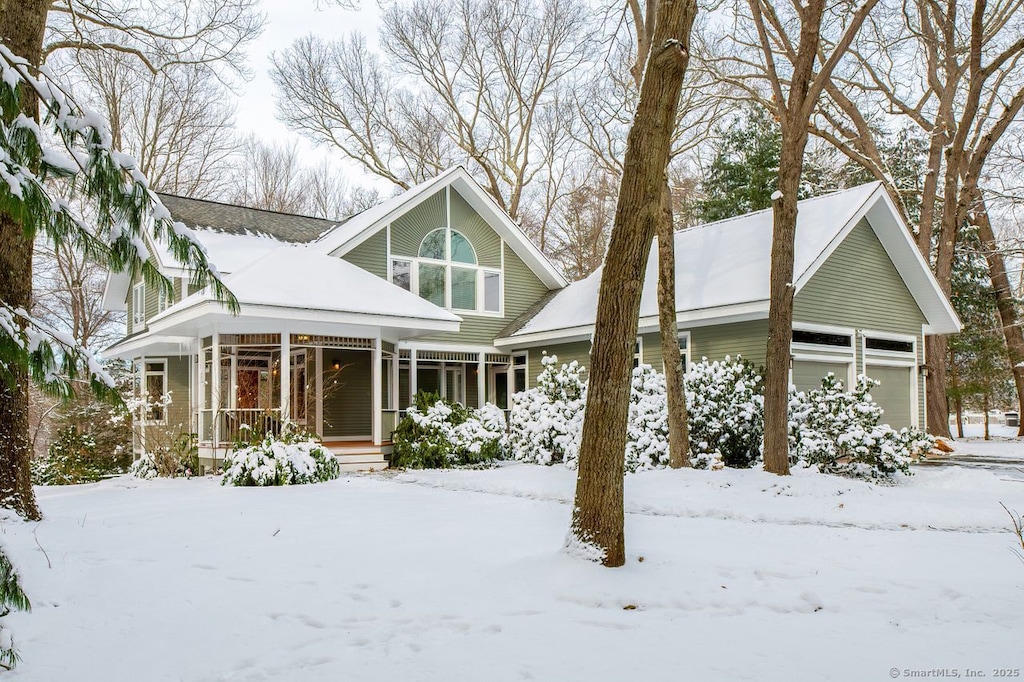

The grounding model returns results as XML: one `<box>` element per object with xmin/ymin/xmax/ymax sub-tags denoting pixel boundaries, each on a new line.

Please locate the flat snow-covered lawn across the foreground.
<box><xmin>2</xmin><ymin>465</ymin><xmax>1024</xmax><ymax>682</ymax></box>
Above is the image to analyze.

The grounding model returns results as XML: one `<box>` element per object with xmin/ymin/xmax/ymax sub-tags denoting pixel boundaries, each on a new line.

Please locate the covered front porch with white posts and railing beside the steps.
<box><xmin>193</xmin><ymin>332</ymin><xmax>398</xmax><ymax>459</ymax></box>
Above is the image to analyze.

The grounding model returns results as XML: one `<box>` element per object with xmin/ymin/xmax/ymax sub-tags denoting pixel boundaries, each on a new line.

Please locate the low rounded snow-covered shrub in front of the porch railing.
<box><xmin>220</xmin><ymin>429</ymin><xmax>341</xmax><ymax>485</ymax></box>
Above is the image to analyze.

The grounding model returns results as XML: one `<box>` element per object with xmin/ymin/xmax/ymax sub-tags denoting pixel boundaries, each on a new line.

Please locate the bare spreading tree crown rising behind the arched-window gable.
<box><xmin>271</xmin><ymin>0</ymin><xmax>593</xmax><ymax>225</ymax></box>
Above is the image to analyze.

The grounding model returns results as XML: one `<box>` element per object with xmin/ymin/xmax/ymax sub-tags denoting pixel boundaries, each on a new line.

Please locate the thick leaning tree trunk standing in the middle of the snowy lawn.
<box><xmin>566</xmin><ymin>0</ymin><xmax>696</xmax><ymax>566</ymax></box>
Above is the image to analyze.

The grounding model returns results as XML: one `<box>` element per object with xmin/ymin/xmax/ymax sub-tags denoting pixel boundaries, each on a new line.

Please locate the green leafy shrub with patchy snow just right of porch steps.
<box><xmin>391</xmin><ymin>392</ymin><xmax>505</xmax><ymax>469</ymax></box>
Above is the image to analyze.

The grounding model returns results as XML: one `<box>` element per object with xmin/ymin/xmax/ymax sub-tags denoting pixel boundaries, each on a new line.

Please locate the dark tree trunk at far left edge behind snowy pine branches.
<box><xmin>0</xmin><ymin>0</ymin><xmax>50</xmax><ymax>519</ymax></box>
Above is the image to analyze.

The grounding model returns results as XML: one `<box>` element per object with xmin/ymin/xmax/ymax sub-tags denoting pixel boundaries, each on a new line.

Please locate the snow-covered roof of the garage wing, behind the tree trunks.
<box><xmin>496</xmin><ymin>182</ymin><xmax>959</xmax><ymax>346</ymax></box>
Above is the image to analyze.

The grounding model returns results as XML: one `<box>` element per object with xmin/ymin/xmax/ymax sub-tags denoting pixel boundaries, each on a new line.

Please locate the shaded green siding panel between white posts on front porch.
<box><xmin>324</xmin><ymin>349</ymin><xmax>373</xmax><ymax>437</ymax></box>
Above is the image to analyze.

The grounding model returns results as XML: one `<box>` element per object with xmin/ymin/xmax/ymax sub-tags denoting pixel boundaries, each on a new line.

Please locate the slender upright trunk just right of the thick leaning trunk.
<box><xmin>657</xmin><ymin>182</ymin><xmax>690</xmax><ymax>469</ymax></box>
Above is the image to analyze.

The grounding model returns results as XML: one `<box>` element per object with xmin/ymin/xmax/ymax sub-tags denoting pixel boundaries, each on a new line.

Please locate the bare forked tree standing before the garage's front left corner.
<box><xmin>717</xmin><ymin>0</ymin><xmax>878</xmax><ymax>474</ymax></box>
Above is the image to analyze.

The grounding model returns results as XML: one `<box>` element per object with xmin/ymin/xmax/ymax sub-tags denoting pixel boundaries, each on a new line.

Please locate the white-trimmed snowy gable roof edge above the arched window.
<box><xmin>310</xmin><ymin>166</ymin><xmax>566</xmax><ymax>289</ymax></box>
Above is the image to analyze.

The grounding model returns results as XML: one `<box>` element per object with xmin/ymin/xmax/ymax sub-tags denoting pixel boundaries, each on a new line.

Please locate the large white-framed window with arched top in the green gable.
<box><xmin>391</xmin><ymin>227</ymin><xmax>502</xmax><ymax>313</ymax></box>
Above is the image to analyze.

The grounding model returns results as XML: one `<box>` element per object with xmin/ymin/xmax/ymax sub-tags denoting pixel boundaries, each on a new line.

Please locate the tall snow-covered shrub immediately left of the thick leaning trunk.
<box><xmin>507</xmin><ymin>354</ymin><xmax>587</xmax><ymax>468</ymax></box>
